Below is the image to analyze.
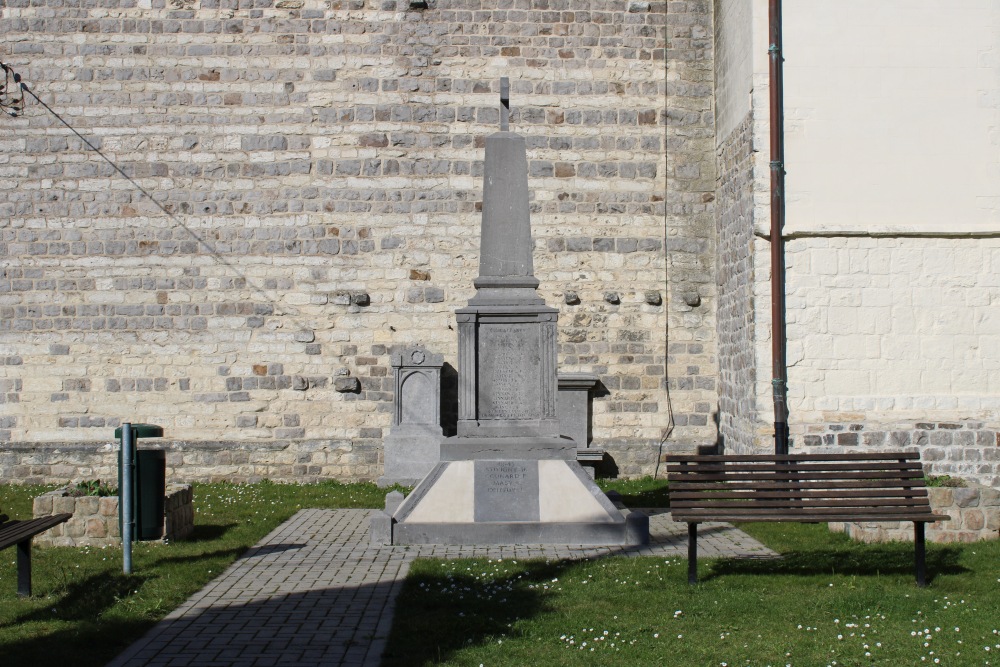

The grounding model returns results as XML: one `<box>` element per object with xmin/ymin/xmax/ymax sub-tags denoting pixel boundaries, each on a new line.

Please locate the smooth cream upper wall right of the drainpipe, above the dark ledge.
<box><xmin>784</xmin><ymin>0</ymin><xmax>1000</xmax><ymax>234</ymax></box>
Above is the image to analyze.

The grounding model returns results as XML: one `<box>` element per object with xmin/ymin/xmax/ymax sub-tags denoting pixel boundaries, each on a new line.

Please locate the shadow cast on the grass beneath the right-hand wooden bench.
<box><xmin>701</xmin><ymin>545</ymin><xmax>969</xmax><ymax>583</ymax></box>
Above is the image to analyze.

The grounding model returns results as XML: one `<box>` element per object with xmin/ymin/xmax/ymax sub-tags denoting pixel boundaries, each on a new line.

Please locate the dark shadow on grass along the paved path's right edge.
<box><xmin>381</xmin><ymin>561</ymin><xmax>572</xmax><ymax>667</ymax></box>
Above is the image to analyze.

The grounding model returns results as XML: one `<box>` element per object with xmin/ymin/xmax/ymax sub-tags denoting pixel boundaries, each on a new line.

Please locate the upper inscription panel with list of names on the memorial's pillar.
<box><xmin>476</xmin><ymin>324</ymin><xmax>542</xmax><ymax>420</ymax></box>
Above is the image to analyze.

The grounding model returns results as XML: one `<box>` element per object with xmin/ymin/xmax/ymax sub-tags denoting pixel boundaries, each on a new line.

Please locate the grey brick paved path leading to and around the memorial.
<box><xmin>108</xmin><ymin>509</ymin><xmax>775</xmax><ymax>667</ymax></box>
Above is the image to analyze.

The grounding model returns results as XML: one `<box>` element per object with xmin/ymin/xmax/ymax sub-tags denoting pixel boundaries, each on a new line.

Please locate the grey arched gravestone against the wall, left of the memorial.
<box><xmin>378</xmin><ymin>347</ymin><xmax>444</xmax><ymax>486</ymax></box>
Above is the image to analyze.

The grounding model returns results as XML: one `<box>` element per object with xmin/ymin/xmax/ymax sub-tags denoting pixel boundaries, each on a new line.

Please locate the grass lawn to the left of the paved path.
<box><xmin>0</xmin><ymin>482</ymin><xmax>386</xmax><ymax>667</ymax></box>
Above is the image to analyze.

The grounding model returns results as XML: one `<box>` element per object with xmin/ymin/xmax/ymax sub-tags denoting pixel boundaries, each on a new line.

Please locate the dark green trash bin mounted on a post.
<box><xmin>115</xmin><ymin>424</ymin><xmax>167</xmax><ymax>540</ymax></box>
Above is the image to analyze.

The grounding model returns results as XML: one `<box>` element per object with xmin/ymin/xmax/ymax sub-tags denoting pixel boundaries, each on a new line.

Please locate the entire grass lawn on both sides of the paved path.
<box><xmin>0</xmin><ymin>480</ymin><xmax>1000</xmax><ymax>667</ymax></box>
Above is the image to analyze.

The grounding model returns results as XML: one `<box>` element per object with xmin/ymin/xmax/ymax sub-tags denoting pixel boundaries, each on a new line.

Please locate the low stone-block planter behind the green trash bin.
<box><xmin>32</xmin><ymin>484</ymin><xmax>194</xmax><ymax>547</ymax></box>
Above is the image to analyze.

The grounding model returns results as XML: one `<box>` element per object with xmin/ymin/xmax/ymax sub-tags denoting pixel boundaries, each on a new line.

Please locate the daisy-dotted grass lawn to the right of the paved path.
<box><xmin>383</xmin><ymin>480</ymin><xmax>1000</xmax><ymax>667</ymax></box>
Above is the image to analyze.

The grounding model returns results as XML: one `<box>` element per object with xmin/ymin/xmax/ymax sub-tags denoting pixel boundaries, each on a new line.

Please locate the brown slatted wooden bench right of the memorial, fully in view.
<box><xmin>666</xmin><ymin>452</ymin><xmax>950</xmax><ymax>586</ymax></box>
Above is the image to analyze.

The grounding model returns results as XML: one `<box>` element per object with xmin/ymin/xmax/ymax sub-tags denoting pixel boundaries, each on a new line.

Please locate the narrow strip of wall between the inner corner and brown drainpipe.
<box><xmin>715</xmin><ymin>0</ymin><xmax>773</xmax><ymax>453</ymax></box>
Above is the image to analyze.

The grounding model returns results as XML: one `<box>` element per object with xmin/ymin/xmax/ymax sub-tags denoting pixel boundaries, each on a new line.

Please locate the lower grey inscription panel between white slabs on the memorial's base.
<box><xmin>474</xmin><ymin>460</ymin><xmax>539</xmax><ymax>521</ymax></box>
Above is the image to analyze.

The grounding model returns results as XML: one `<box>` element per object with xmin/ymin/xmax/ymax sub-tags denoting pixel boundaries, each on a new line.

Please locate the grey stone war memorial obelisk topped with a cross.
<box><xmin>372</xmin><ymin>79</ymin><xmax>649</xmax><ymax>544</ymax></box>
